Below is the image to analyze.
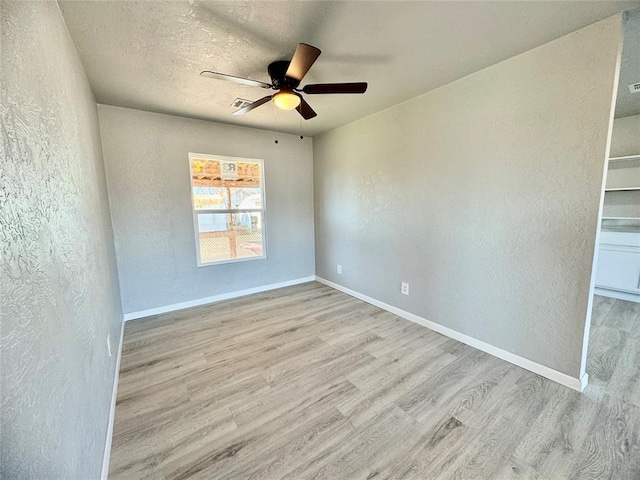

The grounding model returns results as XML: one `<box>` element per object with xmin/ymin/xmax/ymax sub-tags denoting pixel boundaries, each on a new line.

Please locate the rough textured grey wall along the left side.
<box><xmin>0</xmin><ymin>1</ymin><xmax>122</xmax><ymax>480</ymax></box>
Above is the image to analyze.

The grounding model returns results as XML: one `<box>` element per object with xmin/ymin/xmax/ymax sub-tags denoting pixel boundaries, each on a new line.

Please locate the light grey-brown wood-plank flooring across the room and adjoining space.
<box><xmin>110</xmin><ymin>282</ymin><xmax>640</xmax><ymax>480</ymax></box>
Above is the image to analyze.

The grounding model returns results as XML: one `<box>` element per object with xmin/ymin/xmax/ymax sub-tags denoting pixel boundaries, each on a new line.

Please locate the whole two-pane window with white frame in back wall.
<box><xmin>189</xmin><ymin>153</ymin><xmax>266</xmax><ymax>267</ymax></box>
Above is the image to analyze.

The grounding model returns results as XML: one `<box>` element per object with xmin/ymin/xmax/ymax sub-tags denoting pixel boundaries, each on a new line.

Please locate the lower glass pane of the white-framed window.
<box><xmin>198</xmin><ymin>211</ymin><xmax>263</xmax><ymax>263</ymax></box>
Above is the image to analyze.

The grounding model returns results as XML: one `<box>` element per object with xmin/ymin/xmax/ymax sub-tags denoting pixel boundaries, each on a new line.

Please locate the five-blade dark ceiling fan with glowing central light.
<box><xmin>200</xmin><ymin>43</ymin><xmax>367</xmax><ymax>120</ymax></box>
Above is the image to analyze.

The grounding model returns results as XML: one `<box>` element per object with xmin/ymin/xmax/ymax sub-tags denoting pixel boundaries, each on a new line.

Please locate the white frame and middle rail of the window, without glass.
<box><xmin>188</xmin><ymin>152</ymin><xmax>267</xmax><ymax>267</ymax></box>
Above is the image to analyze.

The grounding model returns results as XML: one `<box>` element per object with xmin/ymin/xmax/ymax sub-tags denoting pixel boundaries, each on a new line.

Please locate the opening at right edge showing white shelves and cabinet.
<box><xmin>581</xmin><ymin>9</ymin><xmax>640</xmax><ymax>398</ymax></box>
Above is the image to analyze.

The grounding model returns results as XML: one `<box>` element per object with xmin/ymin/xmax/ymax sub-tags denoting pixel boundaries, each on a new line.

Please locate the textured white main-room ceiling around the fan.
<box><xmin>59</xmin><ymin>0</ymin><xmax>640</xmax><ymax>135</ymax></box>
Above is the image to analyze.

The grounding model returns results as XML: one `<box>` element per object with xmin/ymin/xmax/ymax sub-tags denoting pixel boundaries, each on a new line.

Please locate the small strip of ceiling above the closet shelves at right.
<box><xmin>615</xmin><ymin>9</ymin><xmax>640</xmax><ymax>118</ymax></box>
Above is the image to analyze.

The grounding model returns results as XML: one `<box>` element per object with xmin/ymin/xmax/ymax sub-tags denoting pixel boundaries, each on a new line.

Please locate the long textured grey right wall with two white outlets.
<box><xmin>314</xmin><ymin>16</ymin><xmax>621</xmax><ymax>378</ymax></box>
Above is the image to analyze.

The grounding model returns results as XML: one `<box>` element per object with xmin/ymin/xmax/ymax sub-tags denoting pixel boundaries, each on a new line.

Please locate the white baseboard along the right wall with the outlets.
<box><xmin>316</xmin><ymin>277</ymin><xmax>589</xmax><ymax>392</ymax></box>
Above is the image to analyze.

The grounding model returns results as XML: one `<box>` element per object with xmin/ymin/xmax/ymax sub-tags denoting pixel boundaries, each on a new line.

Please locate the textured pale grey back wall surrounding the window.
<box><xmin>98</xmin><ymin>105</ymin><xmax>314</xmax><ymax>313</ymax></box>
